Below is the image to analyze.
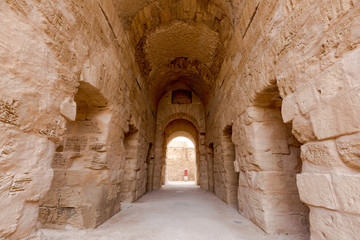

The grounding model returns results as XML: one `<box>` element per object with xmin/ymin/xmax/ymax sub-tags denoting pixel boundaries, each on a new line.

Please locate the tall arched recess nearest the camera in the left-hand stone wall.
<box><xmin>39</xmin><ymin>81</ymin><xmax>114</xmax><ymax>228</ymax></box>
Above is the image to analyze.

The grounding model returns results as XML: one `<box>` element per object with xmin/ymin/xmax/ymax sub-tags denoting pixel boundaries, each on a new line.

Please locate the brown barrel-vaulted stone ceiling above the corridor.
<box><xmin>113</xmin><ymin>0</ymin><xmax>243</xmax><ymax>104</ymax></box>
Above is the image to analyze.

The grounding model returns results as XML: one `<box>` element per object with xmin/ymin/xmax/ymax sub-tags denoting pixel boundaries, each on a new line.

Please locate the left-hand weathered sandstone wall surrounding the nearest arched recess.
<box><xmin>0</xmin><ymin>0</ymin><xmax>155</xmax><ymax>239</ymax></box>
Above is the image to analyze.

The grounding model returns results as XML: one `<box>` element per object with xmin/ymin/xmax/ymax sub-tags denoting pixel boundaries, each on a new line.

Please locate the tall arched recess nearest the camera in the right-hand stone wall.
<box><xmin>232</xmin><ymin>84</ymin><xmax>308</xmax><ymax>234</ymax></box>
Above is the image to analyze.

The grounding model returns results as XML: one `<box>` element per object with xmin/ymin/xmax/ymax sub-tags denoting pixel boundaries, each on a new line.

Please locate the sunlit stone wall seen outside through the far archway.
<box><xmin>166</xmin><ymin>142</ymin><xmax>196</xmax><ymax>181</ymax></box>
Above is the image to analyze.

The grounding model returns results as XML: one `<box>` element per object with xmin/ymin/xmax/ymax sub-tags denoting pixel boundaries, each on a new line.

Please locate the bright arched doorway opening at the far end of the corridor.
<box><xmin>165</xmin><ymin>137</ymin><xmax>197</xmax><ymax>184</ymax></box>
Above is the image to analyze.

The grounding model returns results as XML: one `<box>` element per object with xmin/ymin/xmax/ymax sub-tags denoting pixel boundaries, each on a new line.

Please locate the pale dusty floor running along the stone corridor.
<box><xmin>41</xmin><ymin>183</ymin><xmax>309</xmax><ymax>240</ymax></box>
